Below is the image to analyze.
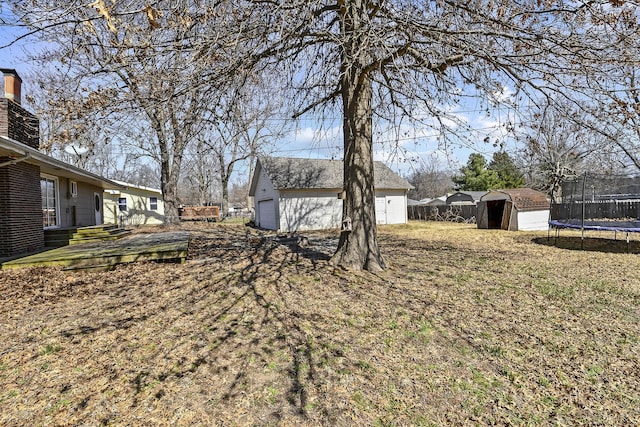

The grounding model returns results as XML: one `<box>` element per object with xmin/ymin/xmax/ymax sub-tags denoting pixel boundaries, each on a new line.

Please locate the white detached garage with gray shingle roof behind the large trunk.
<box><xmin>249</xmin><ymin>157</ymin><xmax>411</xmax><ymax>232</ymax></box>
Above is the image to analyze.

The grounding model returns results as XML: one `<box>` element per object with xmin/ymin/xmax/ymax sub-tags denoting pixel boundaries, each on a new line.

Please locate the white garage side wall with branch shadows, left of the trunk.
<box><xmin>280</xmin><ymin>190</ymin><xmax>342</xmax><ymax>232</ymax></box>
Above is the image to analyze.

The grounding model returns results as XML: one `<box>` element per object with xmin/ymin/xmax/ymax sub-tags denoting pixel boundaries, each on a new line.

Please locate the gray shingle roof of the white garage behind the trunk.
<box><xmin>259</xmin><ymin>157</ymin><xmax>411</xmax><ymax>190</ymax></box>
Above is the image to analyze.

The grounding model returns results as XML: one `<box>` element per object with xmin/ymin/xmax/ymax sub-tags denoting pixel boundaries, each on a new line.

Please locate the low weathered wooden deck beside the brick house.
<box><xmin>0</xmin><ymin>231</ymin><xmax>189</xmax><ymax>270</ymax></box>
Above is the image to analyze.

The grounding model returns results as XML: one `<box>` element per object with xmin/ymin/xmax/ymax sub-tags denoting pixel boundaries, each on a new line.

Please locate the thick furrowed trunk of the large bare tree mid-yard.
<box><xmin>331</xmin><ymin>0</ymin><xmax>385</xmax><ymax>271</ymax></box>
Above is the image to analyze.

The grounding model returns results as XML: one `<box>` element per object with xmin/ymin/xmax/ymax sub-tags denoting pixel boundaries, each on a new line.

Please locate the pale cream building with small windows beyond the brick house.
<box><xmin>104</xmin><ymin>181</ymin><xmax>164</xmax><ymax>226</ymax></box>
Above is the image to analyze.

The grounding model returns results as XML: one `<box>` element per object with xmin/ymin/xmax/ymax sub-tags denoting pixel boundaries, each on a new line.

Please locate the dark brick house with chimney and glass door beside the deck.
<box><xmin>0</xmin><ymin>69</ymin><xmax>119</xmax><ymax>257</ymax></box>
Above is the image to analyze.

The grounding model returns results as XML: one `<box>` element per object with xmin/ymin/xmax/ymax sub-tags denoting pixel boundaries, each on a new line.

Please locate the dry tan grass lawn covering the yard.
<box><xmin>0</xmin><ymin>223</ymin><xmax>640</xmax><ymax>426</ymax></box>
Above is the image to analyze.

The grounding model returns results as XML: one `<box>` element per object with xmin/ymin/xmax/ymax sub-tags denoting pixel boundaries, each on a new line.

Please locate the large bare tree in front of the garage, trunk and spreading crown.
<box><xmin>246</xmin><ymin>0</ymin><xmax>635</xmax><ymax>270</ymax></box>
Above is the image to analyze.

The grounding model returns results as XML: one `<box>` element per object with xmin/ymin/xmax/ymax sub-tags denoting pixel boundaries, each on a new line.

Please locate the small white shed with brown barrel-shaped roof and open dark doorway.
<box><xmin>476</xmin><ymin>188</ymin><xmax>549</xmax><ymax>231</ymax></box>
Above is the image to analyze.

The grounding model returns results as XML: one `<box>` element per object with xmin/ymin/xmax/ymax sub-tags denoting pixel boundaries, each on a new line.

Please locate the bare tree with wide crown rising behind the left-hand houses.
<box><xmin>9</xmin><ymin>0</ymin><xmax>255</xmax><ymax>222</ymax></box>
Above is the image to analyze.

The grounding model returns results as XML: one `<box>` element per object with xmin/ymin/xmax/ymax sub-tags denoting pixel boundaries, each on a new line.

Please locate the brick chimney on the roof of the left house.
<box><xmin>0</xmin><ymin>68</ymin><xmax>40</xmax><ymax>150</ymax></box>
